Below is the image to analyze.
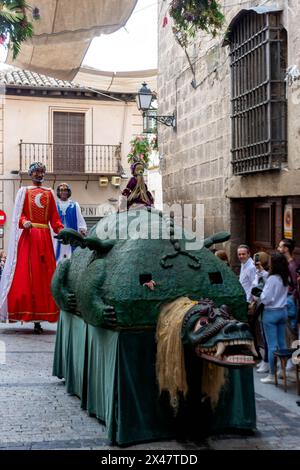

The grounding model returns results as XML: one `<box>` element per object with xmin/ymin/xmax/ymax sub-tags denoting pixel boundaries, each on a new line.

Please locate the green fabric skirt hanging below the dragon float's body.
<box><xmin>53</xmin><ymin>311</ymin><xmax>256</xmax><ymax>445</ymax></box>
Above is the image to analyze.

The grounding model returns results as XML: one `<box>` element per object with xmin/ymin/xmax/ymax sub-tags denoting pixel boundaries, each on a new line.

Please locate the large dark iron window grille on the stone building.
<box><xmin>229</xmin><ymin>11</ymin><xmax>287</xmax><ymax>175</ymax></box>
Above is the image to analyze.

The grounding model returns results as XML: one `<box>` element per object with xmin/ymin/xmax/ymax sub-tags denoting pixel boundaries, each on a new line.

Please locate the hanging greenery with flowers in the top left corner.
<box><xmin>0</xmin><ymin>0</ymin><xmax>40</xmax><ymax>59</ymax></box>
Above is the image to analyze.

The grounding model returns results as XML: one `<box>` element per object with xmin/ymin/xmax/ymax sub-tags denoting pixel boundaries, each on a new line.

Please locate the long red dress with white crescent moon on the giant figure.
<box><xmin>8</xmin><ymin>187</ymin><xmax>63</xmax><ymax>322</ymax></box>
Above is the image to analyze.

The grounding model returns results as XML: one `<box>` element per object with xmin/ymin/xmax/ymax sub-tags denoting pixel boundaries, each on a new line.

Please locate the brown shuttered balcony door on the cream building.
<box><xmin>53</xmin><ymin>112</ymin><xmax>85</xmax><ymax>173</ymax></box>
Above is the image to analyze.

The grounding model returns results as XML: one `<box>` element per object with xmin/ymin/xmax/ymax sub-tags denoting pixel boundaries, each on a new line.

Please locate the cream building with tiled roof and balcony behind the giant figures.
<box><xmin>0</xmin><ymin>66</ymin><xmax>156</xmax><ymax>250</ymax></box>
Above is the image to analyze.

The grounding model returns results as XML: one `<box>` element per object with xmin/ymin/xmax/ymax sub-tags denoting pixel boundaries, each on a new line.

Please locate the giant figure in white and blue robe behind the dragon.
<box><xmin>55</xmin><ymin>183</ymin><xmax>87</xmax><ymax>263</ymax></box>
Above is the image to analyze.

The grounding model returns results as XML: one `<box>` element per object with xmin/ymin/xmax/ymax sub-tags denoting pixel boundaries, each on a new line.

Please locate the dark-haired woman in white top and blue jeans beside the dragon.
<box><xmin>260</xmin><ymin>253</ymin><xmax>289</xmax><ymax>383</ymax></box>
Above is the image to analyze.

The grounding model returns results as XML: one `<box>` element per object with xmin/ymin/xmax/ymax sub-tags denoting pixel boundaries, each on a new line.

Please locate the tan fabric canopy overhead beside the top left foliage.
<box><xmin>6</xmin><ymin>0</ymin><xmax>137</xmax><ymax>80</ymax></box>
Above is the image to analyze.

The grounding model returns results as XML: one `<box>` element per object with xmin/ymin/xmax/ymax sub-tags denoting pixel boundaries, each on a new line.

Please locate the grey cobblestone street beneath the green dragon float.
<box><xmin>0</xmin><ymin>323</ymin><xmax>300</xmax><ymax>451</ymax></box>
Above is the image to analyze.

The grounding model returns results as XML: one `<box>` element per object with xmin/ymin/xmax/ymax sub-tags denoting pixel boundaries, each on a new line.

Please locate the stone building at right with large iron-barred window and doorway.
<box><xmin>158</xmin><ymin>0</ymin><xmax>300</xmax><ymax>262</ymax></box>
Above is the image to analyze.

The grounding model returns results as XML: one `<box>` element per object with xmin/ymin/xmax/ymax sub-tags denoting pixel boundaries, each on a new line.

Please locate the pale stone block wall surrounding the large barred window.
<box><xmin>158</xmin><ymin>0</ymin><xmax>300</xmax><ymax>250</ymax></box>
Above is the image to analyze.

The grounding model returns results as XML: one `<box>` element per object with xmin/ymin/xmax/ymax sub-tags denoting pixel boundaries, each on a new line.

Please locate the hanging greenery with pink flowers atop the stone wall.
<box><xmin>169</xmin><ymin>0</ymin><xmax>224</xmax><ymax>39</ymax></box>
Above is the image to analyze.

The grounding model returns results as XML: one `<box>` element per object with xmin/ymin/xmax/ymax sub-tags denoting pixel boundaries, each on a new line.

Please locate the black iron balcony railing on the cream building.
<box><xmin>19</xmin><ymin>141</ymin><xmax>122</xmax><ymax>175</ymax></box>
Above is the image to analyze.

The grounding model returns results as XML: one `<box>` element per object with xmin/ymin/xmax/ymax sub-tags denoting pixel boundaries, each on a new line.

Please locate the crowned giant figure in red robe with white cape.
<box><xmin>0</xmin><ymin>162</ymin><xmax>63</xmax><ymax>332</ymax></box>
